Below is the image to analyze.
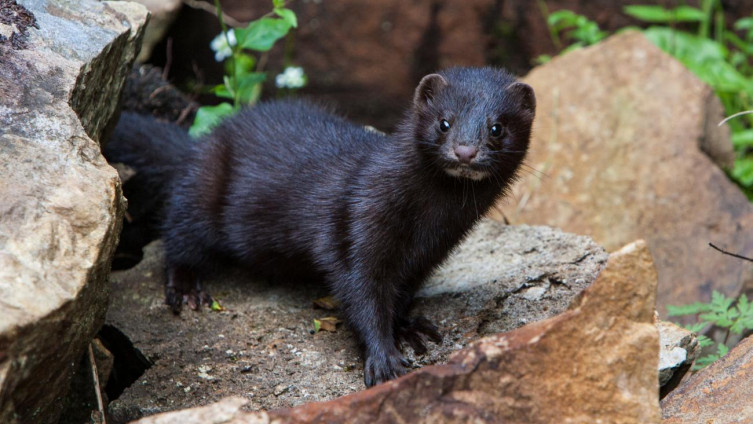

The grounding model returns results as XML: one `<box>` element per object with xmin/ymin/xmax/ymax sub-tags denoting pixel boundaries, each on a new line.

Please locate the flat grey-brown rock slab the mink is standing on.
<box><xmin>107</xmin><ymin>220</ymin><xmax>607</xmax><ymax>423</ymax></box>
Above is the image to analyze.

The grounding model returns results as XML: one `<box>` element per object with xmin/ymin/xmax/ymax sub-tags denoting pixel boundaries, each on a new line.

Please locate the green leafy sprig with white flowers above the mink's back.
<box><xmin>189</xmin><ymin>0</ymin><xmax>298</xmax><ymax>137</ymax></box>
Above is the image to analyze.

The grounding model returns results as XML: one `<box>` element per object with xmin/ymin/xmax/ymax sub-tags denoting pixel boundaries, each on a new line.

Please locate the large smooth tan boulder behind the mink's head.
<box><xmin>495</xmin><ymin>32</ymin><xmax>753</xmax><ymax>314</ymax></box>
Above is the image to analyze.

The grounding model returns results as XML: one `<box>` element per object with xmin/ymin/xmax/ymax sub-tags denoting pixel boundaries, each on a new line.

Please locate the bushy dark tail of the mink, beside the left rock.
<box><xmin>102</xmin><ymin>112</ymin><xmax>196</xmax><ymax>269</ymax></box>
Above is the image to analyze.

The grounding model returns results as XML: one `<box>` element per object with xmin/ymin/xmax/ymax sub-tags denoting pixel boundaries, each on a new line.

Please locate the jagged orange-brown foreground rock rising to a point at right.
<box><xmin>132</xmin><ymin>241</ymin><xmax>660</xmax><ymax>424</ymax></box>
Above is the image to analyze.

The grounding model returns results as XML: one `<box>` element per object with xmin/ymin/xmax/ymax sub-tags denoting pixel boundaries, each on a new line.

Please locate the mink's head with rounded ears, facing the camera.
<box><xmin>409</xmin><ymin>68</ymin><xmax>536</xmax><ymax>181</ymax></box>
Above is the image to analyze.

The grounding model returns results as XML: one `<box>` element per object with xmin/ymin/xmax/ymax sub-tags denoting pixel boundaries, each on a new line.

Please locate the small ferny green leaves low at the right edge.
<box><xmin>667</xmin><ymin>291</ymin><xmax>753</xmax><ymax>370</ymax></box>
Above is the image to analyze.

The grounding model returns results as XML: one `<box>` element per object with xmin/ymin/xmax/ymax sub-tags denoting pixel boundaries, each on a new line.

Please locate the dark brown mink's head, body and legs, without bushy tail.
<box><xmin>108</xmin><ymin>68</ymin><xmax>536</xmax><ymax>386</ymax></box>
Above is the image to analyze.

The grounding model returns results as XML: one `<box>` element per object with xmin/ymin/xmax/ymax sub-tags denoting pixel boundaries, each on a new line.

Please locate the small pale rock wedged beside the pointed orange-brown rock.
<box><xmin>656</xmin><ymin>321</ymin><xmax>701</xmax><ymax>397</ymax></box>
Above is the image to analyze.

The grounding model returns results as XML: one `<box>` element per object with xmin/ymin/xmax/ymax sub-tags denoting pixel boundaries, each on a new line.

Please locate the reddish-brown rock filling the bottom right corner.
<box><xmin>661</xmin><ymin>337</ymin><xmax>753</xmax><ymax>424</ymax></box>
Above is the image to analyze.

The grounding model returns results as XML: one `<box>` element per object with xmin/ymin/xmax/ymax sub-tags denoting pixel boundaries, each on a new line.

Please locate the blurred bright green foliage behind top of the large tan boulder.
<box><xmin>537</xmin><ymin>0</ymin><xmax>753</xmax><ymax>200</ymax></box>
